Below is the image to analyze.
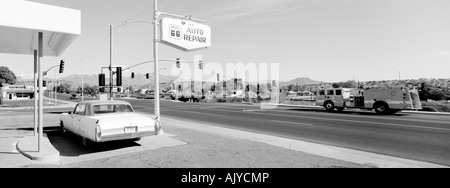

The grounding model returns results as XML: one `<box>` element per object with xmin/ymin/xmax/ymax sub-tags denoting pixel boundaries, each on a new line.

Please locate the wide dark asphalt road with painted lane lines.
<box><xmin>120</xmin><ymin>100</ymin><xmax>450</xmax><ymax>166</ymax></box>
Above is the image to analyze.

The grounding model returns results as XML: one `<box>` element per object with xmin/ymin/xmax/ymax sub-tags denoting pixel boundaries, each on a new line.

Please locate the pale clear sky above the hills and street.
<box><xmin>0</xmin><ymin>0</ymin><xmax>450</xmax><ymax>81</ymax></box>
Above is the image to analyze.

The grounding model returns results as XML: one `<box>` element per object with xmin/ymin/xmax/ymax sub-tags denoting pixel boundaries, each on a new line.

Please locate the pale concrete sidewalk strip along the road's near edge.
<box><xmin>166</xmin><ymin>118</ymin><xmax>447</xmax><ymax>168</ymax></box>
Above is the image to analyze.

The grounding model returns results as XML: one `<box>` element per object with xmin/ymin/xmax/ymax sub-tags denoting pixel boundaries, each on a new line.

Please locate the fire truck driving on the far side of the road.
<box><xmin>316</xmin><ymin>87</ymin><xmax>422</xmax><ymax>114</ymax></box>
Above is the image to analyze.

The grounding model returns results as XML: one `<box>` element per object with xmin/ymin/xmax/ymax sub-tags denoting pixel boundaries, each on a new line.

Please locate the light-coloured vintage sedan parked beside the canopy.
<box><xmin>60</xmin><ymin>101</ymin><xmax>161</xmax><ymax>145</ymax></box>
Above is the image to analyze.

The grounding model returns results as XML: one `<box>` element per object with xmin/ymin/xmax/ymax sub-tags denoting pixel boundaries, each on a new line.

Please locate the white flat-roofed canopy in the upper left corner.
<box><xmin>0</xmin><ymin>0</ymin><xmax>81</xmax><ymax>56</ymax></box>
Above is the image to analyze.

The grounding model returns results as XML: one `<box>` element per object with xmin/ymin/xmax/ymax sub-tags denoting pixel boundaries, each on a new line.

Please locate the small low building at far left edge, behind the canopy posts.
<box><xmin>1</xmin><ymin>85</ymin><xmax>34</xmax><ymax>101</ymax></box>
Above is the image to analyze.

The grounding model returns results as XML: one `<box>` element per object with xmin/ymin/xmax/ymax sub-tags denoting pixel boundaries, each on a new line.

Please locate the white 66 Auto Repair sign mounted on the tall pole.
<box><xmin>161</xmin><ymin>18</ymin><xmax>211</xmax><ymax>52</ymax></box>
